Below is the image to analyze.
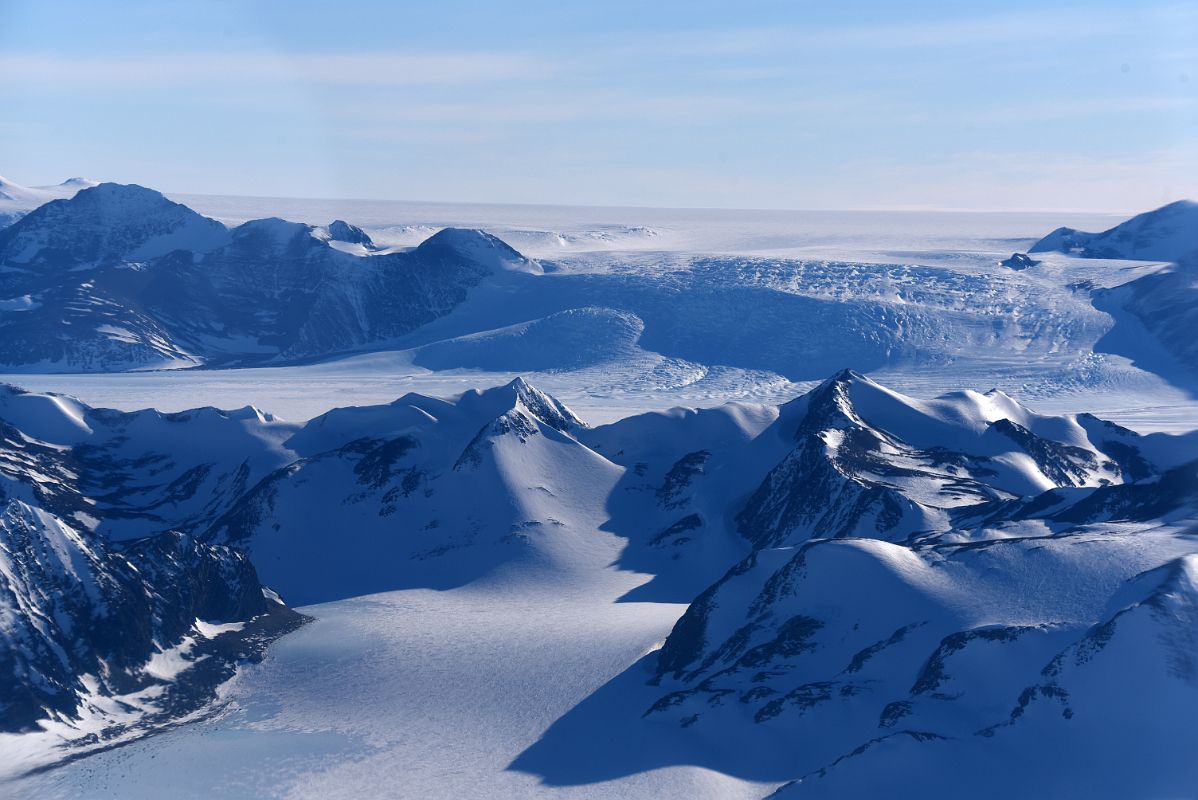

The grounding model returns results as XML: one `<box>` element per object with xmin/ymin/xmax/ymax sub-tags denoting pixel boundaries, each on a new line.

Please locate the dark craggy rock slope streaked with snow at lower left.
<box><xmin>0</xmin><ymin>499</ymin><xmax>301</xmax><ymax>732</ymax></box>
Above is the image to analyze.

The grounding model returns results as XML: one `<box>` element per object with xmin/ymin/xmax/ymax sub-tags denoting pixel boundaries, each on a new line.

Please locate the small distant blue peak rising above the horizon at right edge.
<box><xmin>1028</xmin><ymin>200</ymin><xmax>1198</xmax><ymax>261</ymax></box>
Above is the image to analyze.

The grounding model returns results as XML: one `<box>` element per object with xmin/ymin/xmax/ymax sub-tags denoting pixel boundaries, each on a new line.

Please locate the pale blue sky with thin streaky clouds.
<box><xmin>0</xmin><ymin>0</ymin><xmax>1198</xmax><ymax>212</ymax></box>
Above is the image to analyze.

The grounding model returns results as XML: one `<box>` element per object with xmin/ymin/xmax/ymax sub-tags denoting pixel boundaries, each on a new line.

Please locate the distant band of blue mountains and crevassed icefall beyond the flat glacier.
<box><xmin>0</xmin><ymin>182</ymin><xmax>1198</xmax><ymax>383</ymax></box>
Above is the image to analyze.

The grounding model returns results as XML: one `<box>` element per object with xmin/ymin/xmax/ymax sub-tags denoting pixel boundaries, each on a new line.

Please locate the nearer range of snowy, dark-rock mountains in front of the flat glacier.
<box><xmin>0</xmin><ymin>370</ymin><xmax>1198</xmax><ymax>796</ymax></box>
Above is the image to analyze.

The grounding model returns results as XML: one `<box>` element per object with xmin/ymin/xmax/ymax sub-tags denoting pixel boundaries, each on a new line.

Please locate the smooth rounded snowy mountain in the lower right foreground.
<box><xmin>647</xmin><ymin>526</ymin><xmax>1198</xmax><ymax>798</ymax></box>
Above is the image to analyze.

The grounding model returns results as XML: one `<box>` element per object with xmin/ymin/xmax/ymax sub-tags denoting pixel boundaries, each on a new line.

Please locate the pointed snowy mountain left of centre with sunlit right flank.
<box><xmin>206</xmin><ymin>380</ymin><xmax>608</xmax><ymax>602</ymax></box>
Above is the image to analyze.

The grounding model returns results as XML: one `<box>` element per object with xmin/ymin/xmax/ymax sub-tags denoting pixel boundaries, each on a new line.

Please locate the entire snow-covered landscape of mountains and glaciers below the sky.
<box><xmin>0</xmin><ymin>184</ymin><xmax>1198</xmax><ymax>798</ymax></box>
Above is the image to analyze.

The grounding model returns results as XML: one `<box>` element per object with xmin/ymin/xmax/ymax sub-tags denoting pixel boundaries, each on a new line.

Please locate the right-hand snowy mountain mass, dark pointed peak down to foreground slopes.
<box><xmin>515</xmin><ymin>371</ymin><xmax>1198</xmax><ymax>796</ymax></box>
